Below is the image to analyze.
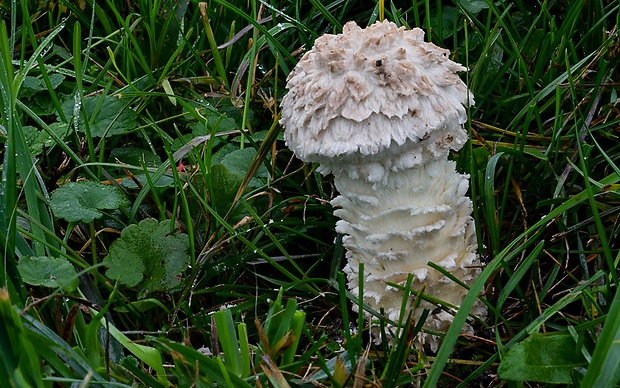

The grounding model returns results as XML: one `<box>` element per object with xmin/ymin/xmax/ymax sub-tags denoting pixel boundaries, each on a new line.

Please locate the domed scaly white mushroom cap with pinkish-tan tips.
<box><xmin>280</xmin><ymin>21</ymin><xmax>473</xmax><ymax>173</ymax></box>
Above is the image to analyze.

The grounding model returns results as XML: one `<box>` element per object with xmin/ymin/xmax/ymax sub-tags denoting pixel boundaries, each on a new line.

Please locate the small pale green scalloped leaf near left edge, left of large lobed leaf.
<box><xmin>17</xmin><ymin>256</ymin><xmax>79</xmax><ymax>291</ymax></box>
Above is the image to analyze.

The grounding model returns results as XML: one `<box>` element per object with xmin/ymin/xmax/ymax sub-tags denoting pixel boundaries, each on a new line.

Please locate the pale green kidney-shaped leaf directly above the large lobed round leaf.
<box><xmin>50</xmin><ymin>182</ymin><xmax>128</xmax><ymax>222</ymax></box>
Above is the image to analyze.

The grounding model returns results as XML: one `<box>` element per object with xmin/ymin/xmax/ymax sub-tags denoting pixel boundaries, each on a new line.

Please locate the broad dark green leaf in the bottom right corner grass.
<box><xmin>498</xmin><ymin>333</ymin><xmax>587</xmax><ymax>384</ymax></box>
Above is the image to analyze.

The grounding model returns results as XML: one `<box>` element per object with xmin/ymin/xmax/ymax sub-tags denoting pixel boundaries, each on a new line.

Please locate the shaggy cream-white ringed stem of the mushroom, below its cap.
<box><xmin>332</xmin><ymin>159</ymin><xmax>480</xmax><ymax>340</ymax></box>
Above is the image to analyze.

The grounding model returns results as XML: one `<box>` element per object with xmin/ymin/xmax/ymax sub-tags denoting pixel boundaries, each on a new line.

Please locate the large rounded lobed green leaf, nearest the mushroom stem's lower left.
<box><xmin>103</xmin><ymin>219</ymin><xmax>189</xmax><ymax>298</ymax></box>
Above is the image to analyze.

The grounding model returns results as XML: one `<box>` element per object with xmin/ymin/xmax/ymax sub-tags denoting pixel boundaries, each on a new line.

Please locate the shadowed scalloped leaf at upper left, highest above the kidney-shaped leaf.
<box><xmin>62</xmin><ymin>95</ymin><xmax>138</xmax><ymax>137</ymax></box>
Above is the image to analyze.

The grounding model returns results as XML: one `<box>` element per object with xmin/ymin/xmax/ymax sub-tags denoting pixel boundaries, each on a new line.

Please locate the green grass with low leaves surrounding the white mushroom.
<box><xmin>0</xmin><ymin>0</ymin><xmax>620</xmax><ymax>387</ymax></box>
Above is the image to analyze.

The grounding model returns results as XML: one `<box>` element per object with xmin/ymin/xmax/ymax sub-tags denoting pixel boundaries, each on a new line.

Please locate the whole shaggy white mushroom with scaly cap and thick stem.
<box><xmin>281</xmin><ymin>21</ymin><xmax>486</xmax><ymax>350</ymax></box>
